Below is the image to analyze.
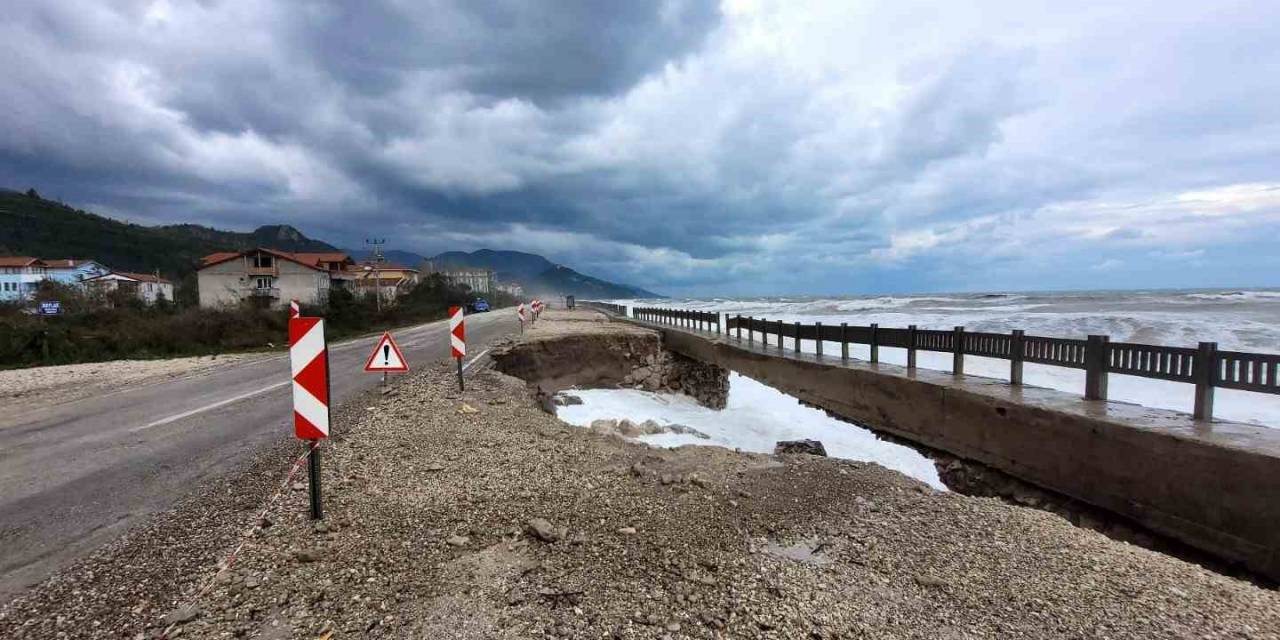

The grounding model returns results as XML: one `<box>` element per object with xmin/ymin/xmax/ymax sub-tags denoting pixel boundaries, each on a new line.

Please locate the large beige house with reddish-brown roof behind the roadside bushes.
<box><xmin>196</xmin><ymin>248</ymin><xmax>355</xmax><ymax>307</ymax></box>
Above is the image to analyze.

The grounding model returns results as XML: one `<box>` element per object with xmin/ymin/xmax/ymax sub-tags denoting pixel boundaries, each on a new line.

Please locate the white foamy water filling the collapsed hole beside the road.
<box><xmin>557</xmin><ymin>374</ymin><xmax>946</xmax><ymax>490</ymax></box>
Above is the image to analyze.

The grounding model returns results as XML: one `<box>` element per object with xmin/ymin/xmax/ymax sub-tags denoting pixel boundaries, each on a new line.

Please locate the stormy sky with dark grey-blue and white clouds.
<box><xmin>0</xmin><ymin>0</ymin><xmax>1280</xmax><ymax>296</ymax></box>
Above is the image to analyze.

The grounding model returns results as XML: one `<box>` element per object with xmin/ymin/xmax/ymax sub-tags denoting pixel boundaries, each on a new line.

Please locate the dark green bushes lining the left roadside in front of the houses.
<box><xmin>0</xmin><ymin>275</ymin><xmax>515</xmax><ymax>369</ymax></box>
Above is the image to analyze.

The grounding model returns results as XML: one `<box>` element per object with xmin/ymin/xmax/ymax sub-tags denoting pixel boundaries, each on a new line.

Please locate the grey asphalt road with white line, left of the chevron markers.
<box><xmin>0</xmin><ymin>310</ymin><xmax>518</xmax><ymax>603</ymax></box>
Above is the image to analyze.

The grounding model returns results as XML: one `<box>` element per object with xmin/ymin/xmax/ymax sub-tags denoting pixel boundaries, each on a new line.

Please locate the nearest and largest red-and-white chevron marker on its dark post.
<box><xmin>289</xmin><ymin>316</ymin><xmax>329</xmax><ymax>520</ymax></box>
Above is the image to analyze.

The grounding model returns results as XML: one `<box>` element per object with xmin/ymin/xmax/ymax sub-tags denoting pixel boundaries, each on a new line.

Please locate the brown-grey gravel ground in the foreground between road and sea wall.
<box><xmin>0</xmin><ymin>350</ymin><xmax>1280</xmax><ymax>639</ymax></box>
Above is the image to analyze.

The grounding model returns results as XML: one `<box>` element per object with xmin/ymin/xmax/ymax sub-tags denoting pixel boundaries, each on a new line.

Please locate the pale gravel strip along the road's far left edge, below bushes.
<box><xmin>0</xmin><ymin>353</ymin><xmax>259</xmax><ymax>407</ymax></box>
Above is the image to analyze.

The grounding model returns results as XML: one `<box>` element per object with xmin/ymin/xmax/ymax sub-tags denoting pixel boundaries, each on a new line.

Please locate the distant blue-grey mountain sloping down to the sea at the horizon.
<box><xmin>431</xmin><ymin>248</ymin><xmax>662</xmax><ymax>300</ymax></box>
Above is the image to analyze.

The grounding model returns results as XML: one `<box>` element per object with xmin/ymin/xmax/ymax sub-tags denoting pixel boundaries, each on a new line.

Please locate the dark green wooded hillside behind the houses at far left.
<box><xmin>0</xmin><ymin>189</ymin><xmax>338</xmax><ymax>278</ymax></box>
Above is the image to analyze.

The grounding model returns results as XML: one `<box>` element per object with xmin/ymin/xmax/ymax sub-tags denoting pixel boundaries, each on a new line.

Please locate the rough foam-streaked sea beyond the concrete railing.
<box><xmin>611</xmin><ymin>289</ymin><xmax>1280</xmax><ymax>428</ymax></box>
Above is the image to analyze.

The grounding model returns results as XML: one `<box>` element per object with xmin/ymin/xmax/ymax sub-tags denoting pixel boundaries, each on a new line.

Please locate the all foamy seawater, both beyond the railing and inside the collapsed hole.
<box><xmin>559</xmin><ymin>289</ymin><xmax>1280</xmax><ymax>489</ymax></box>
